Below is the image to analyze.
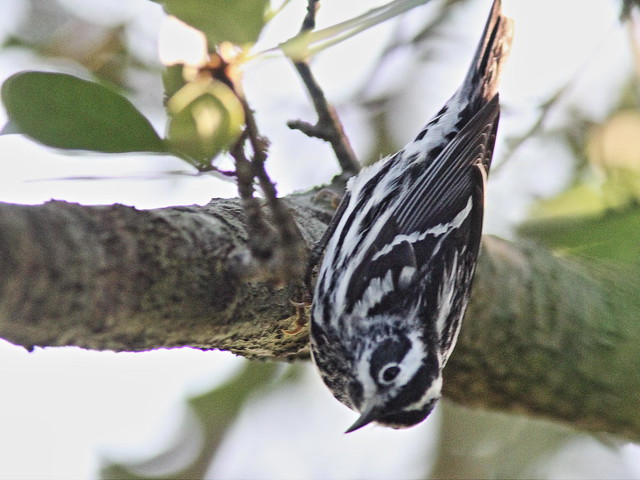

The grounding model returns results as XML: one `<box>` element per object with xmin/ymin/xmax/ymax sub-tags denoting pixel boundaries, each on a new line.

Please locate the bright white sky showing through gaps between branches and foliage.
<box><xmin>0</xmin><ymin>0</ymin><xmax>640</xmax><ymax>479</ymax></box>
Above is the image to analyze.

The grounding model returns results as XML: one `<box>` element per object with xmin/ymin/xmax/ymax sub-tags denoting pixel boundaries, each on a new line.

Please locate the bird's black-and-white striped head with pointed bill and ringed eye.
<box><xmin>347</xmin><ymin>332</ymin><xmax>442</xmax><ymax>433</ymax></box>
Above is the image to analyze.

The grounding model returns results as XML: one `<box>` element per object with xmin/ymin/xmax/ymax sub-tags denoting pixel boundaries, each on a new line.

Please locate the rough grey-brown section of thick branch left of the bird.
<box><xmin>0</xmin><ymin>193</ymin><xmax>331</xmax><ymax>359</ymax></box>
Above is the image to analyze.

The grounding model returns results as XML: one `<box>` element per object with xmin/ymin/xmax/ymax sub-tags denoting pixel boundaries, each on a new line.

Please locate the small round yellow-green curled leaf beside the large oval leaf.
<box><xmin>167</xmin><ymin>78</ymin><xmax>244</xmax><ymax>166</ymax></box>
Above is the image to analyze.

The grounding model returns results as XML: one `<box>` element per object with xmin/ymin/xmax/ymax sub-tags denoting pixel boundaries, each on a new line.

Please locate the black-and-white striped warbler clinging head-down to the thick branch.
<box><xmin>311</xmin><ymin>0</ymin><xmax>511</xmax><ymax>432</ymax></box>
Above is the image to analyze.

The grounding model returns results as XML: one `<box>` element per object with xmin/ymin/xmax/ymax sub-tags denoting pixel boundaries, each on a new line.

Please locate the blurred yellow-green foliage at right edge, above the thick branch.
<box><xmin>518</xmin><ymin>101</ymin><xmax>640</xmax><ymax>268</ymax></box>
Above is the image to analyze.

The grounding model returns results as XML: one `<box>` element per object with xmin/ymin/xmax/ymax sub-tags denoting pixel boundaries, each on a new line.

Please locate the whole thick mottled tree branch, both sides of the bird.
<box><xmin>0</xmin><ymin>193</ymin><xmax>640</xmax><ymax>440</ymax></box>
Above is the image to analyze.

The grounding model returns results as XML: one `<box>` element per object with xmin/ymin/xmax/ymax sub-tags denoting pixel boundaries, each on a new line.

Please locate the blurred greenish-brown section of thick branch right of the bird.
<box><xmin>444</xmin><ymin>237</ymin><xmax>640</xmax><ymax>441</ymax></box>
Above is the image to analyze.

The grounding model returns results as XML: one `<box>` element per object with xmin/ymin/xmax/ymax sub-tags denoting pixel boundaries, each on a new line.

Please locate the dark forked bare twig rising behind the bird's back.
<box><xmin>287</xmin><ymin>0</ymin><xmax>360</xmax><ymax>176</ymax></box>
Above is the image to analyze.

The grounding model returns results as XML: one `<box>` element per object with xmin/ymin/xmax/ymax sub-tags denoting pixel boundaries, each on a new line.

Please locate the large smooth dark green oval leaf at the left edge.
<box><xmin>1</xmin><ymin>72</ymin><xmax>166</xmax><ymax>153</ymax></box>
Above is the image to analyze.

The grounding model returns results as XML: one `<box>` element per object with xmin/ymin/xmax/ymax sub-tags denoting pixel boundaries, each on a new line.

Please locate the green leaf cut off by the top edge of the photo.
<box><xmin>153</xmin><ymin>0</ymin><xmax>269</xmax><ymax>45</ymax></box>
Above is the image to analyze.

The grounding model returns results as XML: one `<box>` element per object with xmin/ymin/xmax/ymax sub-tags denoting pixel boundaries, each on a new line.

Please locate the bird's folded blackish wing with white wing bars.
<box><xmin>346</xmin><ymin>96</ymin><xmax>499</xmax><ymax>315</ymax></box>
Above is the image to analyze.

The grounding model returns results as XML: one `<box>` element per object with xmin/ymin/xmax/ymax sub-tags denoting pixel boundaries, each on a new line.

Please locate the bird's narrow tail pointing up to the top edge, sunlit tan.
<box><xmin>462</xmin><ymin>0</ymin><xmax>513</xmax><ymax>105</ymax></box>
